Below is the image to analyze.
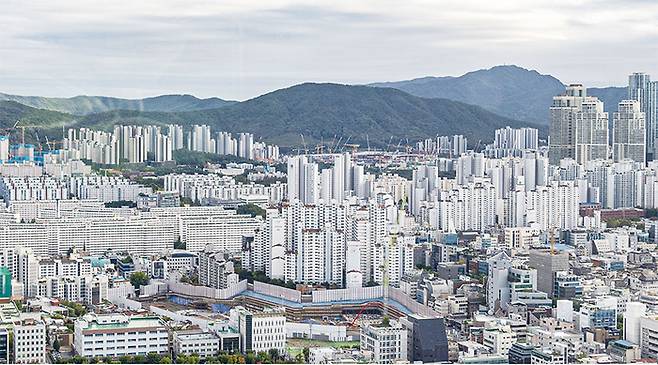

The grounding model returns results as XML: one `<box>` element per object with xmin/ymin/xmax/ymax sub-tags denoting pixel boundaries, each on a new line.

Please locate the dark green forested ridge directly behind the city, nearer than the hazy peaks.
<box><xmin>0</xmin><ymin>83</ymin><xmax>543</xmax><ymax>146</ymax></box>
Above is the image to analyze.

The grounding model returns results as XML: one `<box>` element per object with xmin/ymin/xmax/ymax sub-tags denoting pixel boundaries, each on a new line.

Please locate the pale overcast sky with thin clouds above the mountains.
<box><xmin>0</xmin><ymin>0</ymin><xmax>658</xmax><ymax>100</ymax></box>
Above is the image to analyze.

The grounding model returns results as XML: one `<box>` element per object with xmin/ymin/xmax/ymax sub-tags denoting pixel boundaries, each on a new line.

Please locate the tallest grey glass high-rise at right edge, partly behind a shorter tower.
<box><xmin>628</xmin><ymin>72</ymin><xmax>658</xmax><ymax>161</ymax></box>
